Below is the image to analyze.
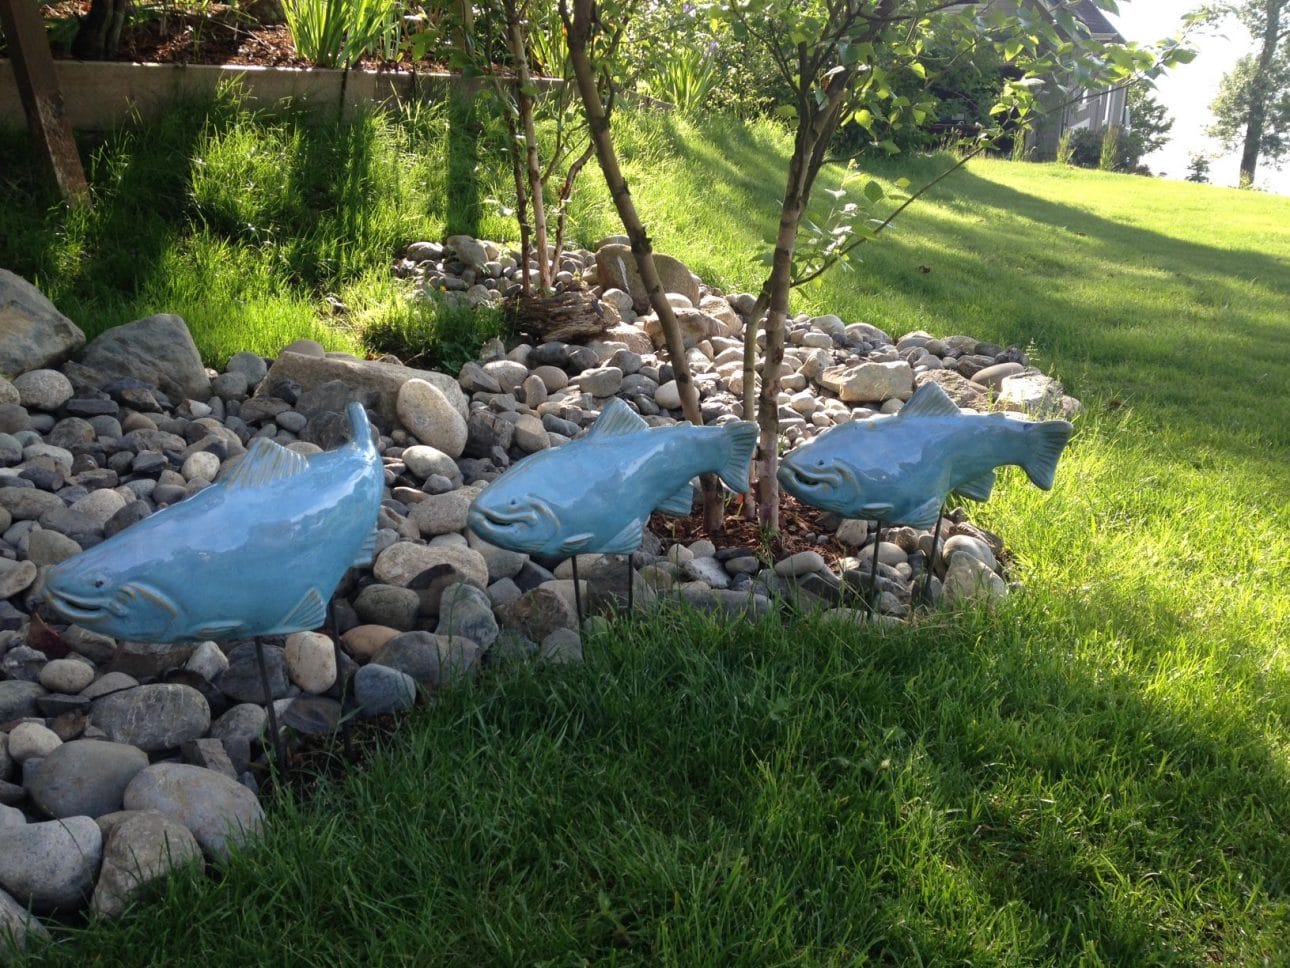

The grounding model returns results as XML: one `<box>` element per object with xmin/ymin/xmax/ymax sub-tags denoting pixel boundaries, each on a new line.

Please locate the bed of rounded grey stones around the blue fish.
<box><xmin>0</xmin><ymin>246</ymin><xmax>1078</xmax><ymax>942</ymax></box>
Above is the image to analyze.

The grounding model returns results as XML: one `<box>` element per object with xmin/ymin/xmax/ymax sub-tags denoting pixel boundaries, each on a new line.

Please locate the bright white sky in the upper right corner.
<box><xmin>1107</xmin><ymin>0</ymin><xmax>1290</xmax><ymax>195</ymax></box>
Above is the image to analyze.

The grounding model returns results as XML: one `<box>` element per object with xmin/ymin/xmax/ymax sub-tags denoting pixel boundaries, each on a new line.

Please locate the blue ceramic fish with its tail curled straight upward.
<box><xmin>44</xmin><ymin>403</ymin><xmax>384</xmax><ymax>641</ymax></box>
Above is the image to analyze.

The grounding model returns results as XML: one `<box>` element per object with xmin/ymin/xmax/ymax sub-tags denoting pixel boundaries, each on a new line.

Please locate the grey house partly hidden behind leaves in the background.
<box><xmin>964</xmin><ymin>0</ymin><xmax>1130</xmax><ymax>160</ymax></box>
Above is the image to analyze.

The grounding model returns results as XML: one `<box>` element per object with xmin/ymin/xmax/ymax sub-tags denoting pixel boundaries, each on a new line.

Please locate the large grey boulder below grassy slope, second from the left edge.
<box><xmin>80</xmin><ymin>312</ymin><xmax>210</xmax><ymax>400</ymax></box>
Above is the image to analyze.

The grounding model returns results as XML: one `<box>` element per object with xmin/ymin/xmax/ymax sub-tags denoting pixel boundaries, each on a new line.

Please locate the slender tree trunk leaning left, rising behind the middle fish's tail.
<box><xmin>560</xmin><ymin>0</ymin><xmax>724</xmax><ymax>534</ymax></box>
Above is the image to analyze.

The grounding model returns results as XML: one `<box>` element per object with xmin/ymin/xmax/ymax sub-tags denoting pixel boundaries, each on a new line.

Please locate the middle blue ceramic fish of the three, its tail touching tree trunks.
<box><xmin>467</xmin><ymin>398</ymin><xmax>757</xmax><ymax>558</ymax></box>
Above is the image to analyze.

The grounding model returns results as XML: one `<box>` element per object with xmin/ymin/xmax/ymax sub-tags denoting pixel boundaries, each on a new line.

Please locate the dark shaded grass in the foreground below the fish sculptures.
<box><xmin>20</xmin><ymin>591</ymin><xmax>1290</xmax><ymax>964</ymax></box>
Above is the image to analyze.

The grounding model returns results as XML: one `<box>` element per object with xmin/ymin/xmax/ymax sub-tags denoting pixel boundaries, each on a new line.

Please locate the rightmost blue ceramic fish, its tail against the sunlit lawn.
<box><xmin>778</xmin><ymin>383</ymin><xmax>1073</xmax><ymax>528</ymax></box>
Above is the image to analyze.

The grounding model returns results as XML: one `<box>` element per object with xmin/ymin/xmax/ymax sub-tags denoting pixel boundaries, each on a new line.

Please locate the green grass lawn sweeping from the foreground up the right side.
<box><xmin>0</xmin><ymin>102</ymin><xmax>1290</xmax><ymax>965</ymax></box>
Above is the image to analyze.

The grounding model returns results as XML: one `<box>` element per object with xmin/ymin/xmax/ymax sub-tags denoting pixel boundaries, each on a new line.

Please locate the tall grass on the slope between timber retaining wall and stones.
<box><xmin>0</xmin><ymin>85</ymin><xmax>507</xmax><ymax>365</ymax></box>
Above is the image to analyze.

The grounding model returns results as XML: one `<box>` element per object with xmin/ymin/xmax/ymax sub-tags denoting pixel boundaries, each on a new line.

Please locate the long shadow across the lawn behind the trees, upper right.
<box><xmin>641</xmin><ymin>116</ymin><xmax>1290</xmax><ymax>474</ymax></box>
